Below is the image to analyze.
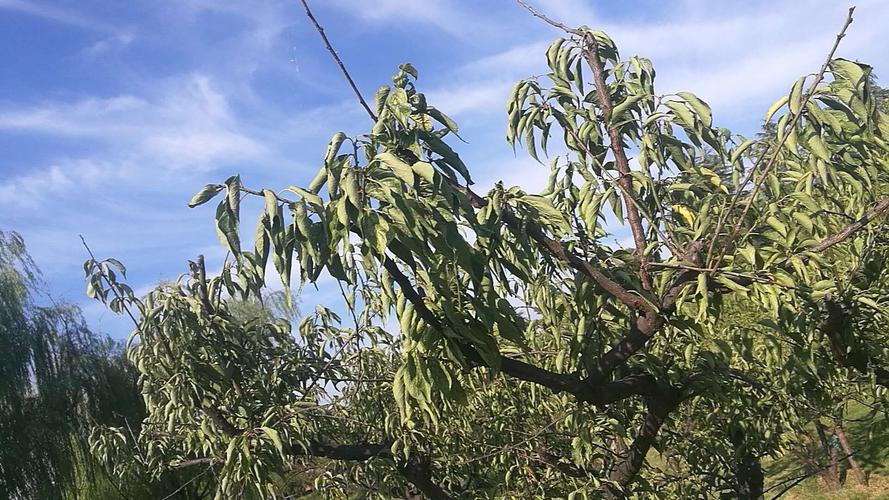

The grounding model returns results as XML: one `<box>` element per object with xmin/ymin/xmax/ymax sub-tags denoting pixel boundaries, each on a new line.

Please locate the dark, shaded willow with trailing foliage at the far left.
<box><xmin>0</xmin><ymin>231</ymin><xmax>215</xmax><ymax>499</ymax></box>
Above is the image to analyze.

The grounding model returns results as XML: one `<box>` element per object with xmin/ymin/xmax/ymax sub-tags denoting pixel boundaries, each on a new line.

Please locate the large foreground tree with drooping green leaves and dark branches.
<box><xmin>90</xmin><ymin>2</ymin><xmax>889</xmax><ymax>498</ymax></box>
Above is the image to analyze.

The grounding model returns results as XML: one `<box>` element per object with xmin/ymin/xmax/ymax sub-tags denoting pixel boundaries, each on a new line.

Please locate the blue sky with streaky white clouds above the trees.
<box><xmin>0</xmin><ymin>0</ymin><xmax>889</xmax><ymax>337</ymax></box>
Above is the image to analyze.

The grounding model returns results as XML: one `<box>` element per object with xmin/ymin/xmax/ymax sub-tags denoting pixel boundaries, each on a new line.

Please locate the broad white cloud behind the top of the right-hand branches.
<box><xmin>426</xmin><ymin>0</ymin><xmax>889</xmax><ymax>121</ymax></box>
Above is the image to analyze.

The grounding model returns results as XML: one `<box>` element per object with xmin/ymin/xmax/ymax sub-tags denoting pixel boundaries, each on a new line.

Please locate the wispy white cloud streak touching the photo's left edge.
<box><xmin>0</xmin><ymin>74</ymin><xmax>267</xmax><ymax>169</ymax></box>
